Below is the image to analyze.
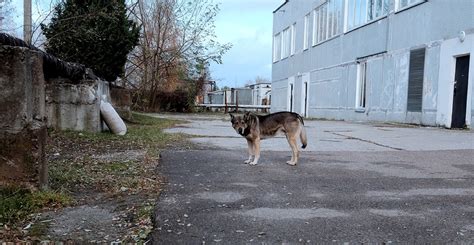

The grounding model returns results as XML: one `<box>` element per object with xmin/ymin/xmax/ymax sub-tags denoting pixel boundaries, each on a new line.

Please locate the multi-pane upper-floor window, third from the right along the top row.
<box><xmin>312</xmin><ymin>0</ymin><xmax>343</xmax><ymax>45</ymax></box>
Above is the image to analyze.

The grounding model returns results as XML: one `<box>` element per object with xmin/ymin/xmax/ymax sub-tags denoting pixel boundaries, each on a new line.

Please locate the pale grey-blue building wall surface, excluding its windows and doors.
<box><xmin>272</xmin><ymin>0</ymin><xmax>474</xmax><ymax>127</ymax></box>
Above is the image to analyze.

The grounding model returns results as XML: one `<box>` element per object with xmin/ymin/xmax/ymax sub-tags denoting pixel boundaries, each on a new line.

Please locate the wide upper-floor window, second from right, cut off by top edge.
<box><xmin>346</xmin><ymin>0</ymin><xmax>390</xmax><ymax>31</ymax></box>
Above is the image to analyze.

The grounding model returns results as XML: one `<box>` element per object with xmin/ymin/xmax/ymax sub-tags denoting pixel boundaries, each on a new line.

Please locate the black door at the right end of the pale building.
<box><xmin>451</xmin><ymin>55</ymin><xmax>469</xmax><ymax>128</ymax></box>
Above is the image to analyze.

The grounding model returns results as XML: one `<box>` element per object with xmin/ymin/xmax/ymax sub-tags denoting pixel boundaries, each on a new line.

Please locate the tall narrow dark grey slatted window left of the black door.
<box><xmin>407</xmin><ymin>48</ymin><xmax>425</xmax><ymax>112</ymax></box>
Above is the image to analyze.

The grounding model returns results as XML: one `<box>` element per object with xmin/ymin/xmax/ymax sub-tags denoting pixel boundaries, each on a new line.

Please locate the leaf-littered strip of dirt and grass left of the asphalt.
<box><xmin>0</xmin><ymin>113</ymin><xmax>186</xmax><ymax>243</ymax></box>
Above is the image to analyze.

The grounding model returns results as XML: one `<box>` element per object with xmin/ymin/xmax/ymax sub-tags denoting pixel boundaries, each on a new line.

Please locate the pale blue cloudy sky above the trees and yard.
<box><xmin>5</xmin><ymin>0</ymin><xmax>284</xmax><ymax>87</ymax></box>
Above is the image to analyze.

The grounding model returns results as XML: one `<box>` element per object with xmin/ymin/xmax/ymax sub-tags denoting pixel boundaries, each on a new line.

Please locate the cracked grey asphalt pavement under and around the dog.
<box><xmin>152</xmin><ymin>114</ymin><xmax>474</xmax><ymax>244</ymax></box>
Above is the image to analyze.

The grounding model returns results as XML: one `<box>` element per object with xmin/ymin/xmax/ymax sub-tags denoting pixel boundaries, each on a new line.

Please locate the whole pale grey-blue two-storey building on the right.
<box><xmin>271</xmin><ymin>0</ymin><xmax>474</xmax><ymax>128</ymax></box>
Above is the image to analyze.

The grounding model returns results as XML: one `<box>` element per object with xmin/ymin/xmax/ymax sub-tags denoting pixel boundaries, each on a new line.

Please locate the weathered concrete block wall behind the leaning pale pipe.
<box><xmin>46</xmin><ymin>78</ymin><xmax>110</xmax><ymax>132</ymax></box>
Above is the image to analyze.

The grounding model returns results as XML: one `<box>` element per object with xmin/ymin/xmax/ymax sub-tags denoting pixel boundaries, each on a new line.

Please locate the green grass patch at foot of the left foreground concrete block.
<box><xmin>0</xmin><ymin>187</ymin><xmax>72</xmax><ymax>224</ymax></box>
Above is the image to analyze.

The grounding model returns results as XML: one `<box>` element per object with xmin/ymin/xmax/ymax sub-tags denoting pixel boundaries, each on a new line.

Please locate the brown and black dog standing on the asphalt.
<box><xmin>229</xmin><ymin>112</ymin><xmax>308</xmax><ymax>165</ymax></box>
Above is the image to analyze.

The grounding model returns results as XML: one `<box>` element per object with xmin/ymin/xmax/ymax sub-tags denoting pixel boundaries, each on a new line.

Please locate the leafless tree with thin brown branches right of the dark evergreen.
<box><xmin>126</xmin><ymin>0</ymin><xmax>231</xmax><ymax>108</ymax></box>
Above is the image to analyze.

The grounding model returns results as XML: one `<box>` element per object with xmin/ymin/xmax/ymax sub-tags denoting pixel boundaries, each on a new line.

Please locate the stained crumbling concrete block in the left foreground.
<box><xmin>0</xmin><ymin>46</ymin><xmax>48</xmax><ymax>187</ymax></box>
